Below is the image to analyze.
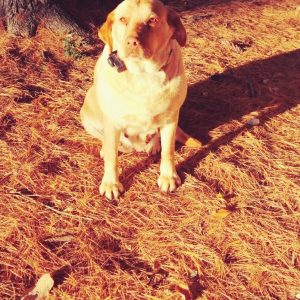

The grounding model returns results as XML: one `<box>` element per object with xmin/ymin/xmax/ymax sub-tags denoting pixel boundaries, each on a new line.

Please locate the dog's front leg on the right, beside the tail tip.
<box><xmin>158</xmin><ymin>117</ymin><xmax>181</xmax><ymax>192</ymax></box>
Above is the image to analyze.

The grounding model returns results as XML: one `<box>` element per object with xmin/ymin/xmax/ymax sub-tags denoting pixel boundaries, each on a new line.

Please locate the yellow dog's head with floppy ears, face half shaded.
<box><xmin>99</xmin><ymin>0</ymin><xmax>186</xmax><ymax>60</ymax></box>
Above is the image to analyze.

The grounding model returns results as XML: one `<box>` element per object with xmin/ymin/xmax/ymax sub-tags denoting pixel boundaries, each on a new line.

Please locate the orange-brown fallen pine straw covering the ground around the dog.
<box><xmin>0</xmin><ymin>0</ymin><xmax>300</xmax><ymax>300</ymax></box>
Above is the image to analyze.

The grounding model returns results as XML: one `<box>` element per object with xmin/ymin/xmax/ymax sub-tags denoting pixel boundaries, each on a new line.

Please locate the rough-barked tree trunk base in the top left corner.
<box><xmin>0</xmin><ymin>0</ymin><xmax>85</xmax><ymax>37</ymax></box>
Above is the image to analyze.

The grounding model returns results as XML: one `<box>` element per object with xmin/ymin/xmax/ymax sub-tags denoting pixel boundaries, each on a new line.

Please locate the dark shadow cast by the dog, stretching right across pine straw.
<box><xmin>122</xmin><ymin>50</ymin><xmax>300</xmax><ymax>189</ymax></box>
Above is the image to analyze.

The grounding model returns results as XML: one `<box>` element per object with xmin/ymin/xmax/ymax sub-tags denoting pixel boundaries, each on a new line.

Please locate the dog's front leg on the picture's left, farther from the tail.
<box><xmin>99</xmin><ymin>117</ymin><xmax>124</xmax><ymax>200</ymax></box>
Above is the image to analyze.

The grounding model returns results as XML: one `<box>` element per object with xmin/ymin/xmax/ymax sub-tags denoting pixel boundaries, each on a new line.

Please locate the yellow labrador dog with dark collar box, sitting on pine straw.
<box><xmin>80</xmin><ymin>0</ymin><xmax>199</xmax><ymax>199</ymax></box>
